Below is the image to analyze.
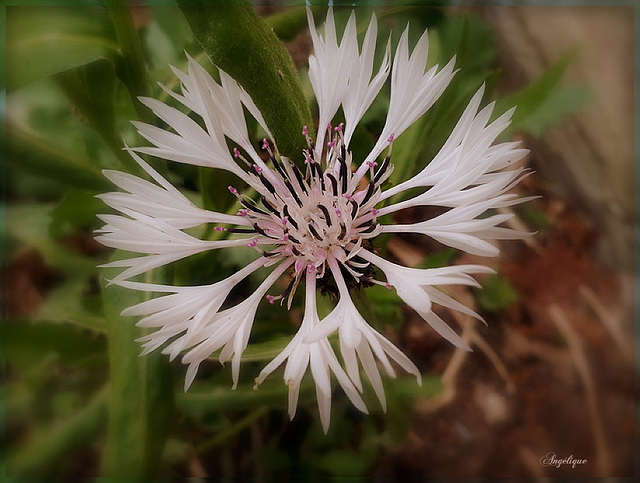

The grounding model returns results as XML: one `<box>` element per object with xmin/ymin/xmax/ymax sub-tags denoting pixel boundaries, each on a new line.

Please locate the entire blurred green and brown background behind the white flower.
<box><xmin>2</xmin><ymin>1</ymin><xmax>636</xmax><ymax>480</ymax></box>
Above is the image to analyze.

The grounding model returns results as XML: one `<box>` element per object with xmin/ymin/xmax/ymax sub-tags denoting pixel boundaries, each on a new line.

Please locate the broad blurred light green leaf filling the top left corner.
<box><xmin>6</xmin><ymin>6</ymin><xmax>118</xmax><ymax>92</ymax></box>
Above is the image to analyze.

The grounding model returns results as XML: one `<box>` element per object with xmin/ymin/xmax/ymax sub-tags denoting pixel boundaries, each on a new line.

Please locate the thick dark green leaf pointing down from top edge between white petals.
<box><xmin>178</xmin><ymin>0</ymin><xmax>313</xmax><ymax>160</ymax></box>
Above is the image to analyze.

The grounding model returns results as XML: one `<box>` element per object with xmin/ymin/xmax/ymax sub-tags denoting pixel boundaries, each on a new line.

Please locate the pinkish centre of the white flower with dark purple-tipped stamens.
<box><xmin>229</xmin><ymin>125</ymin><xmax>392</xmax><ymax>302</ymax></box>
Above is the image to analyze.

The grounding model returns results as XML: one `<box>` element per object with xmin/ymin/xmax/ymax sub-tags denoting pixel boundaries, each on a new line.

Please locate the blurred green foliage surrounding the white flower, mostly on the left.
<box><xmin>3</xmin><ymin>0</ymin><xmax>588</xmax><ymax>478</ymax></box>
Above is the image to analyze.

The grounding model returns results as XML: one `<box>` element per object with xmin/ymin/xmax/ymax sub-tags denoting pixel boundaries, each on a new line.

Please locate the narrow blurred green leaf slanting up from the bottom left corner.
<box><xmin>7</xmin><ymin>389</ymin><xmax>107</xmax><ymax>477</ymax></box>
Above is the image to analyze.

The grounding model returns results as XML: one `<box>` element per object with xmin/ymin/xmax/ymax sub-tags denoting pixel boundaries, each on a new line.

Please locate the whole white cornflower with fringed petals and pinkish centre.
<box><xmin>96</xmin><ymin>9</ymin><xmax>526</xmax><ymax>431</ymax></box>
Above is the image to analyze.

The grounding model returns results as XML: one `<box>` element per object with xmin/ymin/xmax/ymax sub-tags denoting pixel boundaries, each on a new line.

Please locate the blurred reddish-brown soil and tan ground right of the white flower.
<box><xmin>370</xmin><ymin>7</ymin><xmax>635</xmax><ymax>479</ymax></box>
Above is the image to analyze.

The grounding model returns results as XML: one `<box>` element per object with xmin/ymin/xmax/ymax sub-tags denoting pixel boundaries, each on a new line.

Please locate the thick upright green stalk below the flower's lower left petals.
<box><xmin>103</xmin><ymin>266</ymin><xmax>173</xmax><ymax>477</ymax></box>
